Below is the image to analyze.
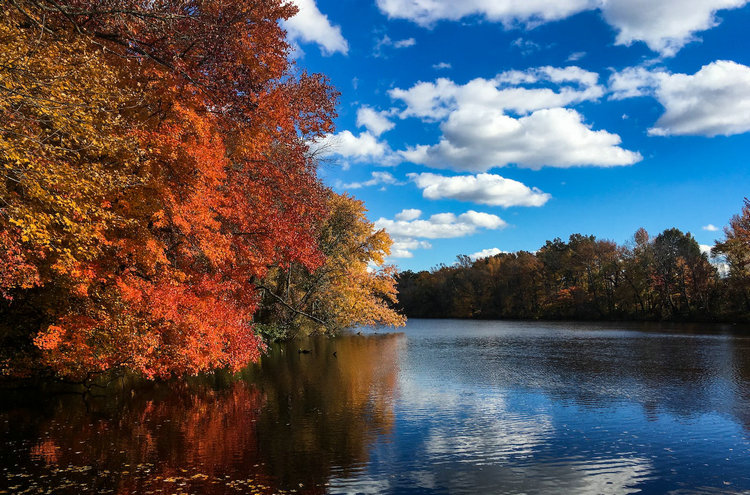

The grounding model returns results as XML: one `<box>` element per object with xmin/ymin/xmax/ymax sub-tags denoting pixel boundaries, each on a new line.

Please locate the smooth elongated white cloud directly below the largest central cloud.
<box><xmin>408</xmin><ymin>173</ymin><xmax>551</xmax><ymax>208</ymax></box>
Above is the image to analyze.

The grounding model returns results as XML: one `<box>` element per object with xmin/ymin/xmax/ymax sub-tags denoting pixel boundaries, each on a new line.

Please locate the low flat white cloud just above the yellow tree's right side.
<box><xmin>375</xmin><ymin>210</ymin><xmax>507</xmax><ymax>239</ymax></box>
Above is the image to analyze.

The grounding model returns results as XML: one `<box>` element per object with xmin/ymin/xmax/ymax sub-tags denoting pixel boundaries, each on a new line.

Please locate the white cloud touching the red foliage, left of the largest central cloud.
<box><xmin>308</xmin><ymin>131</ymin><xmax>398</xmax><ymax>167</ymax></box>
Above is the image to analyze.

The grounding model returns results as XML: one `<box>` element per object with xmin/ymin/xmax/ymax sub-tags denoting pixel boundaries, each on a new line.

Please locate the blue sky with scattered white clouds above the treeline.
<box><xmin>286</xmin><ymin>0</ymin><xmax>750</xmax><ymax>270</ymax></box>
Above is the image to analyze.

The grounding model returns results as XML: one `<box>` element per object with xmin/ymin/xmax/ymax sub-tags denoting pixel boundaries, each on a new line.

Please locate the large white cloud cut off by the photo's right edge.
<box><xmin>609</xmin><ymin>60</ymin><xmax>750</xmax><ymax>137</ymax></box>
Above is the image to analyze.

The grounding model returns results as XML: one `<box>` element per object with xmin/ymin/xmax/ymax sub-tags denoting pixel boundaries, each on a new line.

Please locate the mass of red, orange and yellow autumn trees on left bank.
<box><xmin>0</xmin><ymin>0</ymin><xmax>403</xmax><ymax>381</ymax></box>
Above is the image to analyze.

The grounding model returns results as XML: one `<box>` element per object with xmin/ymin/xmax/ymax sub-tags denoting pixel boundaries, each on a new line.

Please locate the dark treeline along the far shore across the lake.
<box><xmin>398</xmin><ymin>199</ymin><xmax>750</xmax><ymax>322</ymax></box>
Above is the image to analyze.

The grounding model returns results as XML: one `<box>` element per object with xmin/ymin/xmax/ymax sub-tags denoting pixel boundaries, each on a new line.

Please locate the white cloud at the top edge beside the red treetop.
<box><xmin>283</xmin><ymin>0</ymin><xmax>349</xmax><ymax>55</ymax></box>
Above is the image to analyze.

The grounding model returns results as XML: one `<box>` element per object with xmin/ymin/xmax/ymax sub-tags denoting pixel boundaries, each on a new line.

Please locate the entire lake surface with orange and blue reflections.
<box><xmin>0</xmin><ymin>320</ymin><xmax>750</xmax><ymax>494</ymax></box>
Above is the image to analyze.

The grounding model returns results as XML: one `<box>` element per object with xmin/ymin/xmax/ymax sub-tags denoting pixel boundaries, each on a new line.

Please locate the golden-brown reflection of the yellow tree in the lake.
<box><xmin>247</xmin><ymin>334</ymin><xmax>405</xmax><ymax>486</ymax></box>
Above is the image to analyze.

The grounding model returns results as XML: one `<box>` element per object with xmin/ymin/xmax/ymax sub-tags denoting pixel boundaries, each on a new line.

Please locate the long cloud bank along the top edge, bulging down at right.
<box><xmin>377</xmin><ymin>0</ymin><xmax>748</xmax><ymax>56</ymax></box>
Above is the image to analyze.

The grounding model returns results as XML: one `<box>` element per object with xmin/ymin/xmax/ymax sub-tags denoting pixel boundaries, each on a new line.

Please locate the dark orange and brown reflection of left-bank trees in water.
<box><xmin>0</xmin><ymin>334</ymin><xmax>403</xmax><ymax>494</ymax></box>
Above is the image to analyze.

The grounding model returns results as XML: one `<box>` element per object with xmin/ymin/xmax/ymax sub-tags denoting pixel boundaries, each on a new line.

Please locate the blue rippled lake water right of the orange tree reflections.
<box><xmin>364</xmin><ymin>321</ymin><xmax>750</xmax><ymax>493</ymax></box>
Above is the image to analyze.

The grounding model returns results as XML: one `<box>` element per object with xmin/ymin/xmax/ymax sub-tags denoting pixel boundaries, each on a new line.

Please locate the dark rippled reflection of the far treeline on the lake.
<box><xmin>402</xmin><ymin>320</ymin><xmax>750</xmax><ymax>424</ymax></box>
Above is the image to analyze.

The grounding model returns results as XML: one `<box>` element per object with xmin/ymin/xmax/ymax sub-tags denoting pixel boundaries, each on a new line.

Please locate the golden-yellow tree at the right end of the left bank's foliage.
<box><xmin>259</xmin><ymin>191</ymin><xmax>405</xmax><ymax>338</ymax></box>
